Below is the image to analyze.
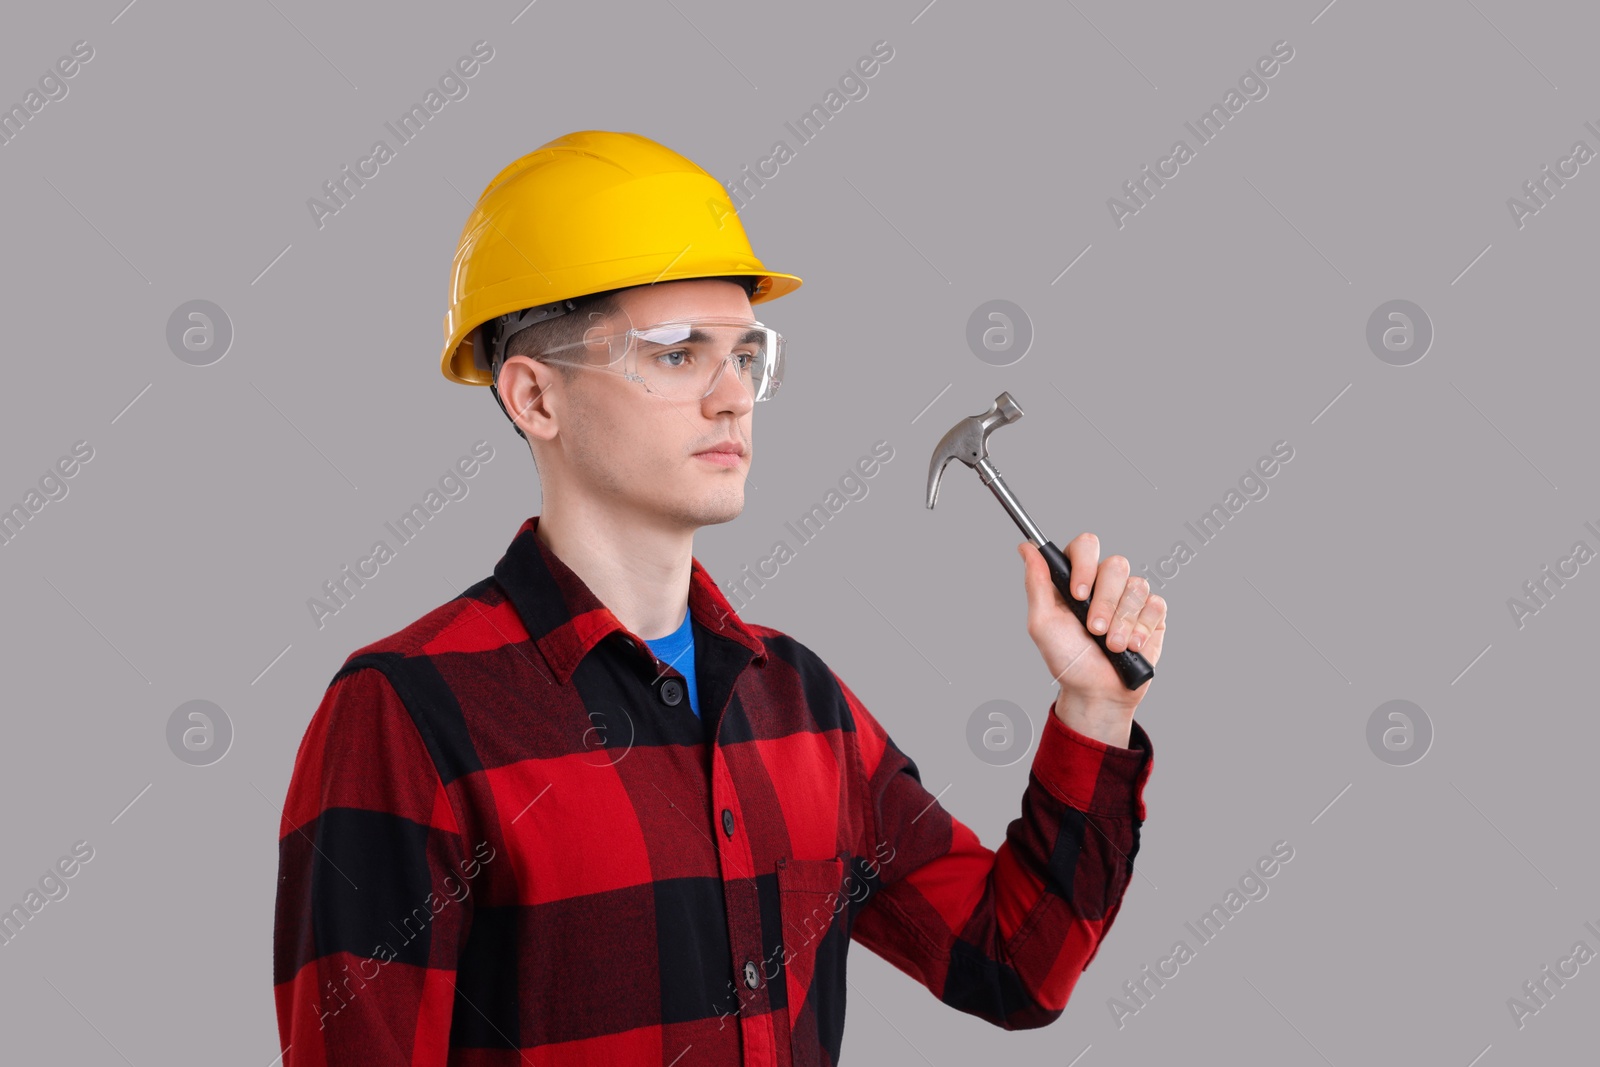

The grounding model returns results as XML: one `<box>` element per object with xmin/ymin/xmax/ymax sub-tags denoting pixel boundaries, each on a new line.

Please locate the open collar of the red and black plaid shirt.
<box><xmin>494</xmin><ymin>515</ymin><xmax>766</xmax><ymax>685</ymax></box>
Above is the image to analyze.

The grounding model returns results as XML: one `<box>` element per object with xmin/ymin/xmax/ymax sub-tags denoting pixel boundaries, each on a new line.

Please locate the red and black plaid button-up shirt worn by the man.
<box><xmin>274</xmin><ymin>515</ymin><xmax>1152</xmax><ymax>1067</ymax></box>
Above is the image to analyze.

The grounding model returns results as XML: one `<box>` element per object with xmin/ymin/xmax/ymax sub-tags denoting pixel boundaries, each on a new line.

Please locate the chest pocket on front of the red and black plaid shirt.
<box><xmin>778</xmin><ymin>857</ymin><xmax>850</xmax><ymax>1067</ymax></box>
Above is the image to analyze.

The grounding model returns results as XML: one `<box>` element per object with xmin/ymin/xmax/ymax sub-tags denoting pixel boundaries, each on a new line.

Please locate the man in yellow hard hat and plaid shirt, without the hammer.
<box><xmin>274</xmin><ymin>131</ymin><xmax>1166</xmax><ymax>1067</ymax></box>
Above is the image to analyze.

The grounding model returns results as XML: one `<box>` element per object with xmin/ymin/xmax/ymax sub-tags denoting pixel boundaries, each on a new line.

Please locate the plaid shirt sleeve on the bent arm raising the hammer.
<box><xmin>835</xmin><ymin>675</ymin><xmax>1154</xmax><ymax>1030</ymax></box>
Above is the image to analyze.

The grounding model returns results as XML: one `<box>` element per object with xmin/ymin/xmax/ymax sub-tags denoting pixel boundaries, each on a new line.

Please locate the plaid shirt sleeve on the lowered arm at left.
<box><xmin>272</xmin><ymin>667</ymin><xmax>483</xmax><ymax>1067</ymax></box>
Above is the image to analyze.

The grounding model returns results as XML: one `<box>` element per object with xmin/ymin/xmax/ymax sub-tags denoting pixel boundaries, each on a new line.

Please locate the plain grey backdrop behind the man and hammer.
<box><xmin>0</xmin><ymin>0</ymin><xmax>1600</xmax><ymax>1067</ymax></box>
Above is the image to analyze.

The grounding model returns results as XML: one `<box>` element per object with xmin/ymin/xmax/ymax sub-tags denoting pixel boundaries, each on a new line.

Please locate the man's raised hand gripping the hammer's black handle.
<box><xmin>1018</xmin><ymin>531</ymin><xmax>1166</xmax><ymax>749</ymax></box>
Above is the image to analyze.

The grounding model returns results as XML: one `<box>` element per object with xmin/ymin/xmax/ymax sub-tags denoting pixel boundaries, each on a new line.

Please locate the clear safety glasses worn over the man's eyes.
<box><xmin>536</xmin><ymin>318</ymin><xmax>784</xmax><ymax>400</ymax></box>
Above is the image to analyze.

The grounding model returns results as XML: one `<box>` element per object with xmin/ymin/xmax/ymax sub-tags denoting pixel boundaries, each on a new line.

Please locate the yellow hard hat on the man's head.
<box><xmin>440</xmin><ymin>130</ymin><xmax>800</xmax><ymax>386</ymax></box>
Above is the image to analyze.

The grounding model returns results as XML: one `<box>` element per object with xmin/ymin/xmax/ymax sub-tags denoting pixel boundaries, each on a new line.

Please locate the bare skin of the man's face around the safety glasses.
<box><xmin>554</xmin><ymin>278</ymin><xmax>757</xmax><ymax>530</ymax></box>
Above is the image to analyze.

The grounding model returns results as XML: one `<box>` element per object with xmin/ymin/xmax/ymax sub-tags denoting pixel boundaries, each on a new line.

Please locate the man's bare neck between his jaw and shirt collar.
<box><xmin>534</xmin><ymin>509</ymin><xmax>694</xmax><ymax>641</ymax></box>
